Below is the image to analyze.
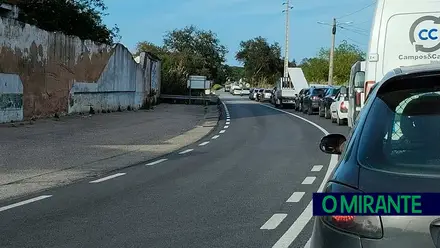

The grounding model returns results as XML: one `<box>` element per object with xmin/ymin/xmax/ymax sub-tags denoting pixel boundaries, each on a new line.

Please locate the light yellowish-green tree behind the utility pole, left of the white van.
<box><xmin>300</xmin><ymin>40</ymin><xmax>365</xmax><ymax>85</ymax></box>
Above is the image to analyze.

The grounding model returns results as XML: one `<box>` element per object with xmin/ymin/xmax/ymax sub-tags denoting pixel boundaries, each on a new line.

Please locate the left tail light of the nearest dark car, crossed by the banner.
<box><xmin>321</xmin><ymin>183</ymin><xmax>383</xmax><ymax>239</ymax></box>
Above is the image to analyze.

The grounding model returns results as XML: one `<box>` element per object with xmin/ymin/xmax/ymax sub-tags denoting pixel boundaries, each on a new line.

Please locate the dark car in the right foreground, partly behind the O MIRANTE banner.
<box><xmin>310</xmin><ymin>65</ymin><xmax>440</xmax><ymax>248</ymax></box>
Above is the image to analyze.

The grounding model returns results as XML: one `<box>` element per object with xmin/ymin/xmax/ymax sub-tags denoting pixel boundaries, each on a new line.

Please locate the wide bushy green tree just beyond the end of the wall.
<box><xmin>136</xmin><ymin>26</ymin><xmax>229</xmax><ymax>94</ymax></box>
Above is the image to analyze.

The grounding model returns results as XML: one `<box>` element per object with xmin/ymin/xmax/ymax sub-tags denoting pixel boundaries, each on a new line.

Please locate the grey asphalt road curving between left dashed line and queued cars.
<box><xmin>0</xmin><ymin>95</ymin><xmax>348</xmax><ymax>248</ymax></box>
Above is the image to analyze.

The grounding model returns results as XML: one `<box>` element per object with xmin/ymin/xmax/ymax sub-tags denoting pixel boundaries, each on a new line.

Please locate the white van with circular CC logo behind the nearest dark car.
<box><xmin>362</xmin><ymin>0</ymin><xmax>440</xmax><ymax>101</ymax></box>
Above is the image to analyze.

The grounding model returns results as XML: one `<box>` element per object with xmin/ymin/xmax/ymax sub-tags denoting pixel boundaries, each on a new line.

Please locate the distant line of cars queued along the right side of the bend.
<box><xmin>249</xmin><ymin>85</ymin><xmax>348</xmax><ymax>125</ymax></box>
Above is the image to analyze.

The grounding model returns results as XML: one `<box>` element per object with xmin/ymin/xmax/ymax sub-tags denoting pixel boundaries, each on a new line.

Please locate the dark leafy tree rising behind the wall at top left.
<box><xmin>18</xmin><ymin>0</ymin><xmax>121</xmax><ymax>44</ymax></box>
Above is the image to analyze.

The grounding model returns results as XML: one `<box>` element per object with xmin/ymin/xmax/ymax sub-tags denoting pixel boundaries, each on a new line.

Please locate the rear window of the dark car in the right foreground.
<box><xmin>358</xmin><ymin>73</ymin><xmax>440</xmax><ymax>174</ymax></box>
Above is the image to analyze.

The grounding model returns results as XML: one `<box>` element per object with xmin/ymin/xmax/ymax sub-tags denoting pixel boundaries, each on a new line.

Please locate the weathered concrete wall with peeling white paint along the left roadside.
<box><xmin>0</xmin><ymin>18</ymin><xmax>160</xmax><ymax>122</ymax></box>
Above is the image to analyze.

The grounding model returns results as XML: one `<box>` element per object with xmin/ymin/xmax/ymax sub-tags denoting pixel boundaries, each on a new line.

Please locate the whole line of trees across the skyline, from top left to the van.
<box><xmin>8</xmin><ymin>0</ymin><xmax>365</xmax><ymax>94</ymax></box>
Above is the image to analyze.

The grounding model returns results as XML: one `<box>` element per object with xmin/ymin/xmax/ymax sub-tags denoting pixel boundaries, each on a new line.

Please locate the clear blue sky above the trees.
<box><xmin>104</xmin><ymin>0</ymin><xmax>375</xmax><ymax>65</ymax></box>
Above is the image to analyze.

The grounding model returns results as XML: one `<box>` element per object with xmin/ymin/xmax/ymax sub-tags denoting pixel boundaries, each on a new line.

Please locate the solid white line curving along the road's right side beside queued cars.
<box><xmin>261</xmin><ymin>104</ymin><xmax>338</xmax><ymax>248</ymax></box>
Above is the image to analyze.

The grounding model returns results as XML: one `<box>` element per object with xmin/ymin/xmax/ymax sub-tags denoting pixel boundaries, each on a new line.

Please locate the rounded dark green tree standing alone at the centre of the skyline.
<box><xmin>235</xmin><ymin>36</ymin><xmax>283</xmax><ymax>85</ymax></box>
